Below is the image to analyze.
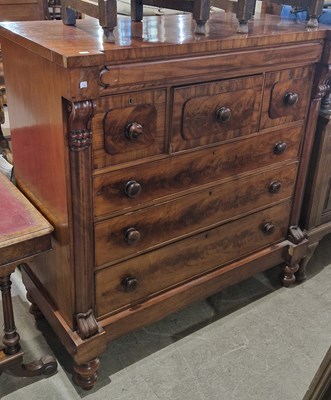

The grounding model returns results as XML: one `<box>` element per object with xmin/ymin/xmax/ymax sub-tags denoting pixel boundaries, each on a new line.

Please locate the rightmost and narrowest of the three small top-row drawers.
<box><xmin>260</xmin><ymin>67</ymin><xmax>313</xmax><ymax>129</ymax></box>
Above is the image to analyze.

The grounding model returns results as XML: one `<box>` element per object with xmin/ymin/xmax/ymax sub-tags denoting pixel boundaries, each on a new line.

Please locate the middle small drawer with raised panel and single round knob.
<box><xmin>173</xmin><ymin>75</ymin><xmax>263</xmax><ymax>151</ymax></box>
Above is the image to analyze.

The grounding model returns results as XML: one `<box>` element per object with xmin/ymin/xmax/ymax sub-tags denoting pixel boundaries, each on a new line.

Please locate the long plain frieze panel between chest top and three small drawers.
<box><xmin>100</xmin><ymin>42</ymin><xmax>321</xmax><ymax>94</ymax></box>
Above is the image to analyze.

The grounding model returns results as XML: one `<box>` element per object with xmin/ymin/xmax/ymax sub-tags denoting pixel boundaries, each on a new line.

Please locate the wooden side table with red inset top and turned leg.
<box><xmin>0</xmin><ymin>173</ymin><xmax>57</xmax><ymax>376</ymax></box>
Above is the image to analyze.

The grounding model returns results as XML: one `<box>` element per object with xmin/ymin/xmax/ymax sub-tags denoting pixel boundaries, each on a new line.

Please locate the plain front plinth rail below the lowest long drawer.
<box><xmin>101</xmin><ymin>242</ymin><xmax>288</xmax><ymax>341</ymax></box>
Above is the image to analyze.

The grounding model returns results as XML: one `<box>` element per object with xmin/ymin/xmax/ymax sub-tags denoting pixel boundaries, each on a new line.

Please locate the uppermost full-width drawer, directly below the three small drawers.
<box><xmin>94</xmin><ymin>127</ymin><xmax>302</xmax><ymax>216</ymax></box>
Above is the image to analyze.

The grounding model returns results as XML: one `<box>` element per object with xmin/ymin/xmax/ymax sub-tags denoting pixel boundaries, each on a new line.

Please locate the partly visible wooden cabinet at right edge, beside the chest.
<box><xmin>298</xmin><ymin>95</ymin><xmax>331</xmax><ymax>280</ymax></box>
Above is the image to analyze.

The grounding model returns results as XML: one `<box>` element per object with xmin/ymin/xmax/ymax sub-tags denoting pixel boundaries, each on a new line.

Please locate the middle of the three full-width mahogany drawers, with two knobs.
<box><xmin>95</xmin><ymin>163</ymin><xmax>297</xmax><ymax>266</ymax></box>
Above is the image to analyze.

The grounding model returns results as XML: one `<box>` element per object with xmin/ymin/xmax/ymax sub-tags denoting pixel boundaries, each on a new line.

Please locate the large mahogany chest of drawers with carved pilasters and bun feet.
<box><xmin>0</xmin><ymin>14</ymin><xmax>329</xmax><ymax>389</ymax></box>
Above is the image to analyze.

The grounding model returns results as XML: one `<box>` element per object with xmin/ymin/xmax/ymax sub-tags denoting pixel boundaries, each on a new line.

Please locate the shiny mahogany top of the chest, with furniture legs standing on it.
<box><xmin>0</xmin><ymin>13</ymin><xmax>327</xmax><ymax>68</ymax></box>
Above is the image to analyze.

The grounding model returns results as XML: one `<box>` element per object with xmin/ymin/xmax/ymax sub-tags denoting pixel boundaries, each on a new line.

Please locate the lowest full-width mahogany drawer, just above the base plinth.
<box><xmin>96</xmin><ymin>201</ymin><xmax>291</xmax><ymax>316</ymax></box>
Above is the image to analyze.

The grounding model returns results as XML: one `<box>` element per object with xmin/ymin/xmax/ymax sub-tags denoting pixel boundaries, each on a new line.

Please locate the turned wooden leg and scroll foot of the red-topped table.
<box><xmin>0</xmin><ymin>275</ymin><xmax>57</xmax><ymax>376</ymax></box>
